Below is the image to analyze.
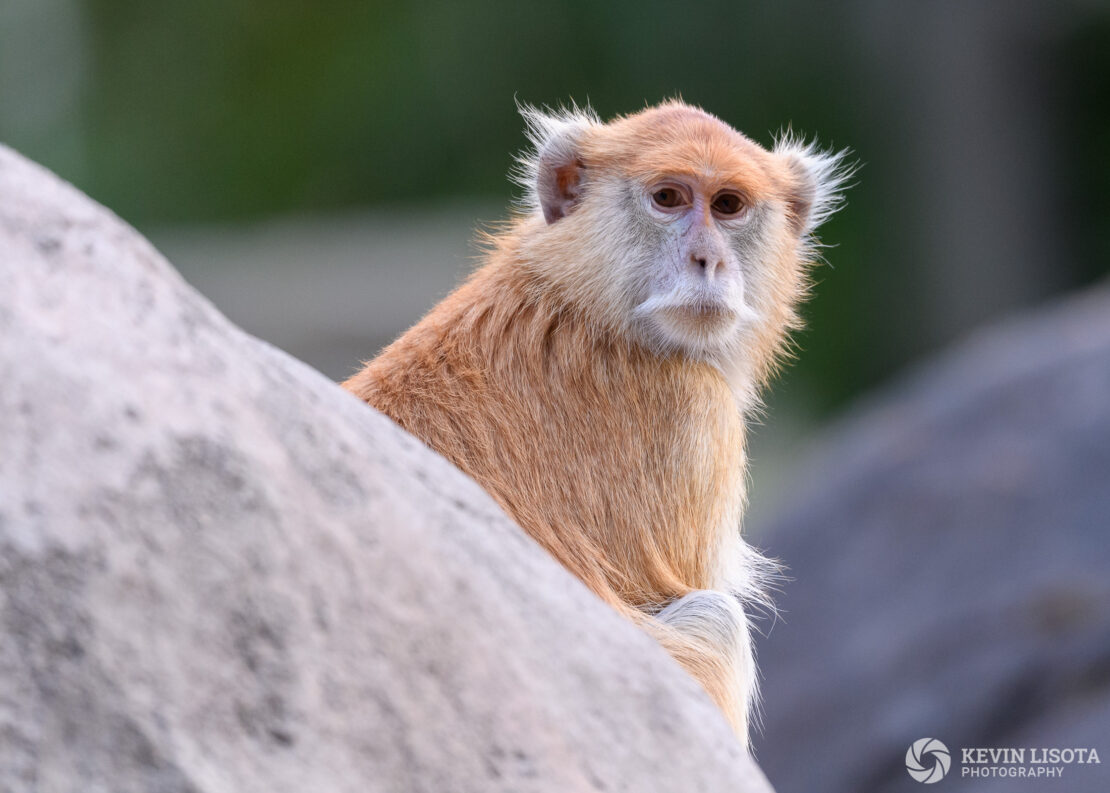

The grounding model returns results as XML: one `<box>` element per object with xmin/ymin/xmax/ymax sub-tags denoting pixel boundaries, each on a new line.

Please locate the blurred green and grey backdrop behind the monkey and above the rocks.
<box><xmin>0</xmin><ymin>0</ymin><xmax>1110</xmax><ymax>515</ymax></box>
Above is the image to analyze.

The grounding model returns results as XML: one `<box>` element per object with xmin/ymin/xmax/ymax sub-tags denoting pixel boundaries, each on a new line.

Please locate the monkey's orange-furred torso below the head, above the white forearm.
<box><xmin>345</xmin><ymin>261</ymin><xmax>743</xmax><ymax>605</ymax></box>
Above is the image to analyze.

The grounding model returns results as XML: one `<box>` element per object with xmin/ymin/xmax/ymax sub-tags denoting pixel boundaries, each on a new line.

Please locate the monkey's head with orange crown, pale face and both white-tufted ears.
<box><xmin>517</xmin><ymin>101</ymin><xmax>848</xmax><ymax>378</ymax></box>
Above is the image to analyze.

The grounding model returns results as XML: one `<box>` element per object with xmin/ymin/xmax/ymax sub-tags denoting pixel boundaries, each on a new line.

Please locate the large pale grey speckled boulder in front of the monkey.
<box><xmin>0</xmin><ymin>143</ymin><xmax>769</xmax><ymax>793</ymax></box>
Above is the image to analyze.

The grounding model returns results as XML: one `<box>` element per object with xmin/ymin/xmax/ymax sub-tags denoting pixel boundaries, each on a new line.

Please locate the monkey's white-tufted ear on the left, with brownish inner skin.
<box><xmin>514</xmin><ymin>104</ymin><xmax>601</xmax><ymax>224</ymax></box>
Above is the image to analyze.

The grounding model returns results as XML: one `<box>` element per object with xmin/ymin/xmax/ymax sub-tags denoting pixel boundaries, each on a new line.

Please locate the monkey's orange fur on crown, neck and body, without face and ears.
<box><xmin>344</xmin><ymin>102</ymin><xmax>843</xmax><ymax>735</ymax></box>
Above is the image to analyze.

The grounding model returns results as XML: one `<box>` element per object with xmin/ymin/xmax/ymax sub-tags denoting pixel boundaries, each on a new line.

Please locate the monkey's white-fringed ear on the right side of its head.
<box><xmin>774</xmin><ymin>131</ymin><xmax>857</xmax><ymax>237</ymax></box>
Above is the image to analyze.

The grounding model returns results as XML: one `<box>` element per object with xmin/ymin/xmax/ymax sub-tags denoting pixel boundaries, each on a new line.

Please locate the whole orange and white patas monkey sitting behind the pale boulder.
<box><xmin>344</xmin><ymin>101</ymin><xmax>845</xmax><ymax>743</ymax></box>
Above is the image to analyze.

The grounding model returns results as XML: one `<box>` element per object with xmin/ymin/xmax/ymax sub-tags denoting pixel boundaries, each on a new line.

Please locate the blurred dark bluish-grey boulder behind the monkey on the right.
<box><xmin>757</xmin><ymin>280</ymin><xmax>1110</xmax><ymax>793</ymax></box>
